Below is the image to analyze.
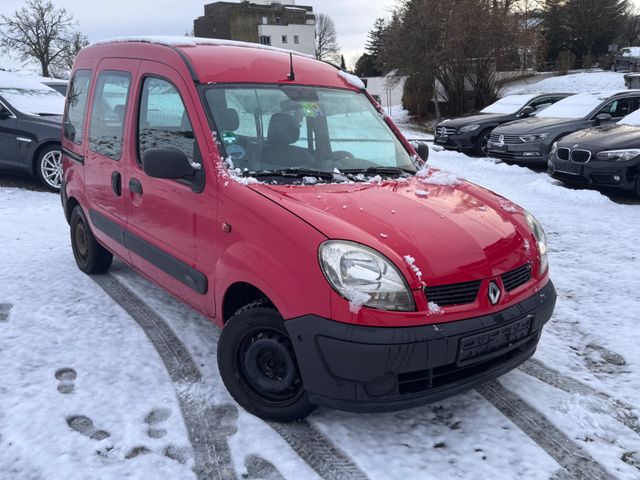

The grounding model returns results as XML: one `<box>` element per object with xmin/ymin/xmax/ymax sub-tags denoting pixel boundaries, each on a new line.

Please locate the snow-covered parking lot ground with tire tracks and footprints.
<box><xmin>0</xmin><ymin>141</ymin><xmax>640</xmax><ymax>480</ymax></box>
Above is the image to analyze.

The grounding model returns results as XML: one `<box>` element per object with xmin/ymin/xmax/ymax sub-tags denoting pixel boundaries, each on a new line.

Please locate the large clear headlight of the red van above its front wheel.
<box><xmin>318</xmin><ymin>240</ymin><xmax>415</xmax><ymax>313</ymax></box>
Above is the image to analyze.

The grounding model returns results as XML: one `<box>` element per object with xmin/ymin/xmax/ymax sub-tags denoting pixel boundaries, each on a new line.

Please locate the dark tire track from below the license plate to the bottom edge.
<box><xmin>476</xmin><ymin>381</ymin><xmax>615</xmax><ymax>480</ymax></box>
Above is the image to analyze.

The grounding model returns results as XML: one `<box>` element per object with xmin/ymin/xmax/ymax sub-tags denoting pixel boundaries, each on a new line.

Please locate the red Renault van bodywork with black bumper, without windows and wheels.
<box><xmin>62</xmin><ymin>40</ymin><xmax>555</xmax><ymax>418</ymax></box>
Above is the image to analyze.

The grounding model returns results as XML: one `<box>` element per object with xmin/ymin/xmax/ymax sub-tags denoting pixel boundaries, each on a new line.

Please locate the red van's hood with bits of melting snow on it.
<box><xmin>251</xmin><ymin>170</ymin><xmax>534</xmax><ymax>289</ymax></box>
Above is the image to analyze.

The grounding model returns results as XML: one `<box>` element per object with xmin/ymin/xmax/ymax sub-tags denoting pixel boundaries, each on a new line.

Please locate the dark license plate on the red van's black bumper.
<box><xmin>458</xmin><ymin>315</ymin><xmax>533</xmax><ymax>366</ymax></box>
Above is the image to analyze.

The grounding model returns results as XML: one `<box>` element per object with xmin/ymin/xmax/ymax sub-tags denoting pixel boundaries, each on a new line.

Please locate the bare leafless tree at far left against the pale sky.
<box><xmin>0</xmin><ymin>0</ymin><xmax>73</xmax><ymax>77</ymax></box>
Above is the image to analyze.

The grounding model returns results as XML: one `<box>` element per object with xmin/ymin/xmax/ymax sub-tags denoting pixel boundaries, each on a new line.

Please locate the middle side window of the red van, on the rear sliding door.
<box><xmin>89</xmin><ymin>71</ymin><xmax>131</xmax><ymax>160</ymax></box>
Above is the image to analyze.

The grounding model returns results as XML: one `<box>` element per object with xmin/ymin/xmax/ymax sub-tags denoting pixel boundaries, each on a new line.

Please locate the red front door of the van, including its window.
<box><xmin>125</xmin><ymin>61</ymin><xmax>216</xmax><ymax>312</ymax></box>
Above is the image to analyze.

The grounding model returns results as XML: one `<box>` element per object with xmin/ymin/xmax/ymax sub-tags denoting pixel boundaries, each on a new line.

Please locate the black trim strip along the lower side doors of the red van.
<box><xmin>89</xmin><ymin>210</ymin><xmax>209</xmax><ymax>295</ymax></box>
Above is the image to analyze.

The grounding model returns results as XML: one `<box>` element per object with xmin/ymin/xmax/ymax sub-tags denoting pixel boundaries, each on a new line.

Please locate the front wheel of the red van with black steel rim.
<box><xmin>218</xmin><ymin>299</ymin><xmax>316</xmax><ymax>422</ymax></box>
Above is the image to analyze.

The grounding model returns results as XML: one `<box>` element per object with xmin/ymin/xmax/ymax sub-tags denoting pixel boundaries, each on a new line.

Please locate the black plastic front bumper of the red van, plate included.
<box><xmin>286</xmin><ymin>282</ymin><xmax>556</xmax><ymax>412</ymax></box>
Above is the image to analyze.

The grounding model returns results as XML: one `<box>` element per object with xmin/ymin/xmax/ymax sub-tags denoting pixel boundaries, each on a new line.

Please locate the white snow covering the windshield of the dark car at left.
<box><xmin>0</xmin><ymin>72</ymin><xmax>64</xmax><ymax>115</ymax></box>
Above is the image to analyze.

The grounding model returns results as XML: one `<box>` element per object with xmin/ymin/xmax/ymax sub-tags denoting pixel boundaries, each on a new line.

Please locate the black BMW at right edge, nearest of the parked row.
<box><xmin>548</xmin><ymin>110</ymin><xmax>640</xmax><ymax>197</ymax></box>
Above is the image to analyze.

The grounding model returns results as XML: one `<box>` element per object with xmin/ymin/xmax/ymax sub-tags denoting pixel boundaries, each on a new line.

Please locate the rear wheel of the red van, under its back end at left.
<box><xmin>69</xmin><ymin>206</ymin><xmax>113</xmax><ymax>274</ymax></box>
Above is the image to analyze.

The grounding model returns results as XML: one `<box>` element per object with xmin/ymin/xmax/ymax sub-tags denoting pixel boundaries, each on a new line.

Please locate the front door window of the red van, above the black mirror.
<box><xmin>138</xmin><ymin>77</ymin><xmax>199</xmax><ymax>167</ymax></box>
